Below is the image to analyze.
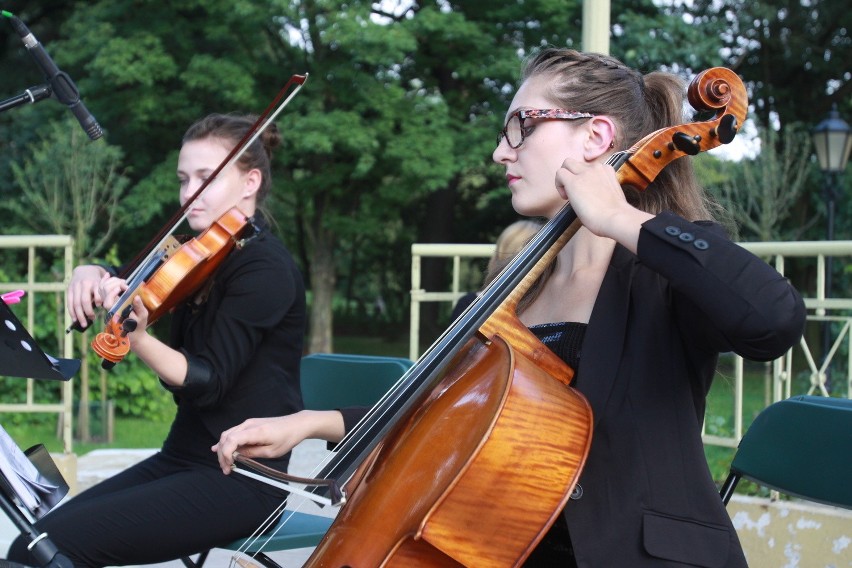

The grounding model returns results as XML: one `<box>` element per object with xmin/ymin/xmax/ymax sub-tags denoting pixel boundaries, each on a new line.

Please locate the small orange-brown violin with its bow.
<box><xmin>83</xmin><ymin>73</ymin><xmax>308</xmax><ymax>369</ymax></box>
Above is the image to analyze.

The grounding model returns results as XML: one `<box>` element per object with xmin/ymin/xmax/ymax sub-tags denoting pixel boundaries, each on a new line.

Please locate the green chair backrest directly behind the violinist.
<box><xmin>301</xmin><ymin>353</ymin><xmax>414</xmax><ymax>410</ymax></box>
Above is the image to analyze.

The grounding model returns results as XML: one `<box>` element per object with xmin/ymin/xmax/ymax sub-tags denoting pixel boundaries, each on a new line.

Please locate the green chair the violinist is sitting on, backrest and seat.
<box><xmin>181</xmin><ymin>353</ymin><xmax>414</xmax><ymax>568</ymax></box>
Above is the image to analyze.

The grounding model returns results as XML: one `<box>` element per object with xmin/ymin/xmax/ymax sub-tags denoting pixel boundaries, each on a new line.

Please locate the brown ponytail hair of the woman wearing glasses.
<box><xmin>521</xmin><ymin>48</ymin><xmax>719</xmax><ymax>221</ymax></box>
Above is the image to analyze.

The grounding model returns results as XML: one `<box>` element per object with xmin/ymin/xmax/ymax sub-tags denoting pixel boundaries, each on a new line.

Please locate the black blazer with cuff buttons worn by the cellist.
<box><xmin>564</xmin><ymin>213</ymin><xmax>805</xmax><ymax>568</ymax></box>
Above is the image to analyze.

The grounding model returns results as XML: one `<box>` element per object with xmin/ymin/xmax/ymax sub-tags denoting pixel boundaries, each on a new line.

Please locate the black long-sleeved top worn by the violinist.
<box><xmin>163</xmin><ymin>224</ymin><xmax>305</xmax><ymax>471</ymax></box>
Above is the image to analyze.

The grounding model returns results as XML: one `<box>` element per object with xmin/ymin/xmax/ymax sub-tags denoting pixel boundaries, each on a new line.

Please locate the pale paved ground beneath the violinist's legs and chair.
<box><xmin>0</xmin><ymin>440</ymin><xmax>334</xmax><ymax>568</ymax></box>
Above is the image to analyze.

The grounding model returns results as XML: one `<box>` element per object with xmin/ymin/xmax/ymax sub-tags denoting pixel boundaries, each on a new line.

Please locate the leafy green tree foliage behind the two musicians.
<box><xmin>0</xmin><ymin>0</ymin><xmax>852</xmax><ymax>356</ymax></box>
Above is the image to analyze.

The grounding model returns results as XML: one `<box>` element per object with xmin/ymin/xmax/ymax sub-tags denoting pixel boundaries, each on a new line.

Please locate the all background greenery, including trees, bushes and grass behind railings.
<box><xmin>0</xmin><ymin>0</ymin><xmax>852</xmax><ymax>494</ymax></box>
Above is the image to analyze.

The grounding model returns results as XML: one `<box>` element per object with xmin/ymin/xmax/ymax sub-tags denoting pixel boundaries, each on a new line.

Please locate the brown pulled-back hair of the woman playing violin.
<box><xmin>182</xmin><ymin>114</ymin><xmax>281</xmax><ymax>210</ymax></box>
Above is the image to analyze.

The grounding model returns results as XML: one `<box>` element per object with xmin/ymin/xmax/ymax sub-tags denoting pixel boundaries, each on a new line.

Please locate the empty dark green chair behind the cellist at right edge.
<box><xmin>720</xmin><ymin>396</ymin><xmax>852</xmax><ymax>509</ymax></box>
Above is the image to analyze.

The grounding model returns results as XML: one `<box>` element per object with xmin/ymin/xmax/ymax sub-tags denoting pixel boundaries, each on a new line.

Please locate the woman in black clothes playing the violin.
<box><xmin>9</xmin><ymin>115</ymin><xmax>305</xmax><ymax>566</ymax></box>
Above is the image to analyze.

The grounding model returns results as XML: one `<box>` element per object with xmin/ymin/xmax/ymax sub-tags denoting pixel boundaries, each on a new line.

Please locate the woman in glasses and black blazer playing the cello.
<box><xmin>214</xmin><ymin>49</ymin><xmax>805</xmax><ymax>568</ymax></box>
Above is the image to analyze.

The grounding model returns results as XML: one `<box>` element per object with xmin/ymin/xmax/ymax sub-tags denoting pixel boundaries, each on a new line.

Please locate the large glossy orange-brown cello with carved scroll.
<box><xmin>233</xmin><ymin>68</ymin><xmax>747</xmax><ymax>568</ymax></box>
